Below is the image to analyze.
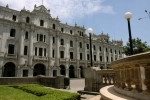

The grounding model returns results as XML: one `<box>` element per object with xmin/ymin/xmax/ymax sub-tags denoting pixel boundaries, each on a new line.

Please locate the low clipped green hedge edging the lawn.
<box><xmin>5</xmin><ymin>84</ymin><xmax>80</xmax><ymax>100</ymax></box>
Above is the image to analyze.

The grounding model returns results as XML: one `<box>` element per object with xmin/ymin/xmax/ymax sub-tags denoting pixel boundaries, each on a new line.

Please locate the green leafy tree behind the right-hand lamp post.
<box><xmin>124</xmin><ymin>38</ymin><xmax>150</xmax><ymax>56</ymax></box>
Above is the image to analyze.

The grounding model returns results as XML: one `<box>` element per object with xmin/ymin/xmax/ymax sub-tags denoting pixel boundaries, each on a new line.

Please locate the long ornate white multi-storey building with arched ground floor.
<box><xmin>0</xmin><ymin>5</ymin><xmax>123</xmax><ymax>78</ymax></box>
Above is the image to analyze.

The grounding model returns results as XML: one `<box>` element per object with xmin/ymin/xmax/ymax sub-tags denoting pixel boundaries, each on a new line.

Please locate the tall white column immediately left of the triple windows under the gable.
<box><xmin>28</xmin><ymin>26</ymin><xmax>34</xmax><ymax>66</ymax></box>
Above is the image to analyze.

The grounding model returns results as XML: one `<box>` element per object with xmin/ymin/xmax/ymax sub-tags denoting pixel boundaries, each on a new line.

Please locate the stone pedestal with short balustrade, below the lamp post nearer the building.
<box><xmin>84</xmin><ymin>67</ymin><xmax>115</xmax><ymax>92</ymax></box>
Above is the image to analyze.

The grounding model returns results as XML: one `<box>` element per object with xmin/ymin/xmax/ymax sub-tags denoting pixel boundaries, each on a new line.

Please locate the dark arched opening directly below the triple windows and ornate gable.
<box><xmin>33</xmin><ymin>63</ymin><xmax>46</xmax><ymax>76</ymax></box>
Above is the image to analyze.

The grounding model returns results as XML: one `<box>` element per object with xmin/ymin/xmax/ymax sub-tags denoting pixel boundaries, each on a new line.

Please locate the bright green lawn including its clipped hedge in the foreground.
<box><xmin>0</xmin><ymin>84</ymin><xmax>80</xmax><ymax>100</ymax></box>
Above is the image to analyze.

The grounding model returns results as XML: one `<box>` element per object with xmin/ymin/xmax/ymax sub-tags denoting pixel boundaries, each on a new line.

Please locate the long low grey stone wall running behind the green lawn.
<box><xmin>0</xmin><ymin>76</ymin><xmax>64</xmax><ymax>89</ymax></box>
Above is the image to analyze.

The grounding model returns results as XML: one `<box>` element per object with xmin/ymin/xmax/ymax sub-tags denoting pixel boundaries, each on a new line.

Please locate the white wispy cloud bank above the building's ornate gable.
<box><xmin>0</xmin><ymin>0</ymin><xmax>115</xmax><ymax>21</ymax></box>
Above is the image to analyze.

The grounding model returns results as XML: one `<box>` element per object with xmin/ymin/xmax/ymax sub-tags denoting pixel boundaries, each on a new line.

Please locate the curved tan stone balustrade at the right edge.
<box><xmin>111</xmin><ymin>52</ymin><xmax>150</xmax><ymax>100</ymax></box>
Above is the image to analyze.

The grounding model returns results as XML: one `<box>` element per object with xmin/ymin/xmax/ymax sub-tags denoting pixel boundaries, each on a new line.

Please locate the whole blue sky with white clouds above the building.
<box><xmin>0</xmin><ymin>0</ymin><xmax>150</xmax><ymax>45</ymax></box>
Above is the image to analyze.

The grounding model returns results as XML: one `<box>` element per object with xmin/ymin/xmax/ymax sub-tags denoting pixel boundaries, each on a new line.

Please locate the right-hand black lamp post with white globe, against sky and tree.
<box><xmin>124</xmin><ymin>12</ymin><xmax>133</xmax><ymax>55</ymax></box>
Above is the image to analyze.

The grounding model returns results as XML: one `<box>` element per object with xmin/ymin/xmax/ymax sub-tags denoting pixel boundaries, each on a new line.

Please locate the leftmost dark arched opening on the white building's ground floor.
<box><xmin>3</xmin><ymin>62</ymin><xmax>16</xmax><ymax>77</ymax></box>
